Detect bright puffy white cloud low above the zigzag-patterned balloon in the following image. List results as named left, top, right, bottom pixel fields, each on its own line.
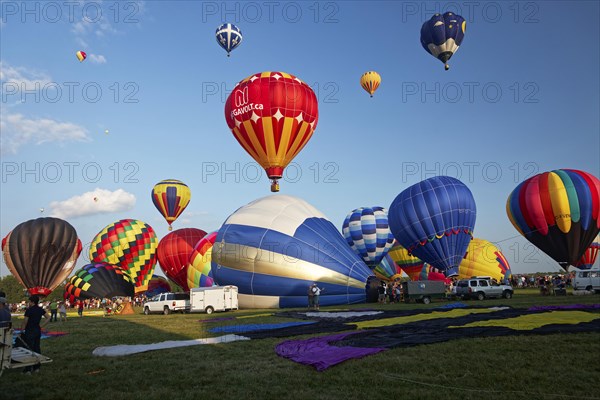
left=50, top=188, right=136, bottom=219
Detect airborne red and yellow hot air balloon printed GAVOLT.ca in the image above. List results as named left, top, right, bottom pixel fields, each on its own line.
left=225, top=72, right=319, bottom=192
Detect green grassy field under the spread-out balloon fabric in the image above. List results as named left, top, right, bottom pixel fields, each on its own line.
left=0, top=289, right=600, bottom=400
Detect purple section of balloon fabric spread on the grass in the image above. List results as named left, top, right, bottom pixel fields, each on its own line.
left=275, top=332, right=387, bottom=371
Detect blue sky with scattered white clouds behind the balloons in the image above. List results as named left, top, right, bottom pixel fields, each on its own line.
left=0, top=1, right=600, bottom=276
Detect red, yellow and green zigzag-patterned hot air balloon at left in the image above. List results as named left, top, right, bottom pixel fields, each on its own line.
left=90, top=219, right=158, bottom=293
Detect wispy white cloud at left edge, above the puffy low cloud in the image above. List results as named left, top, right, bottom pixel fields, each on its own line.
left=0, top=112, right=90, bottom=155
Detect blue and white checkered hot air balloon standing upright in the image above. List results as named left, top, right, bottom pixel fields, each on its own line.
left=342, top=207, right=394, bottom=268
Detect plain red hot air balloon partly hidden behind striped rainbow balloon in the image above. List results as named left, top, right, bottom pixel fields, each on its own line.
left=156, top=228, right=206, bottom=292
